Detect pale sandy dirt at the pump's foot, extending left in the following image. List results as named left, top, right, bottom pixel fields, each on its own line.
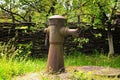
left=12, top=72, right=70, bottom=80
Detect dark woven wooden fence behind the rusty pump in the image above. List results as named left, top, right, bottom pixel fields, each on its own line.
left=0, top=23, right=120, bottom=56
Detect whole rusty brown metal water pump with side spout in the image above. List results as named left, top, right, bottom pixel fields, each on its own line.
left=45, top=15, right=78, bottom=73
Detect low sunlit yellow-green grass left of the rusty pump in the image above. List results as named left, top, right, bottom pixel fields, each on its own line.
left=0, top=58, right=46, bottom=80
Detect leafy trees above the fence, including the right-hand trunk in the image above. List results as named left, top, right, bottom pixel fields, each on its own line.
left=0, top=0, right=120, bottom=56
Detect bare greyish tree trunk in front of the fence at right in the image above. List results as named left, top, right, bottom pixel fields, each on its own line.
left=108, top=29, right=114, bottom=56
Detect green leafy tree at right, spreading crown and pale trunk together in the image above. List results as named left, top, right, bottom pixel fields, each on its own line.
left=58, top=0, right=120, bottom=56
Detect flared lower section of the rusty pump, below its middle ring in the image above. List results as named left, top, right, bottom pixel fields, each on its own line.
left=47, top=44, right=65, bottom=73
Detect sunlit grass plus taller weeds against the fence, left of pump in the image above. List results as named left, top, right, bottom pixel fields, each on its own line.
left=0, top=41, right=46, bottom=80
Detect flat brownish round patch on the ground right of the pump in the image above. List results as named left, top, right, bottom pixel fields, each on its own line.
left=75, top=66, right=120, bottom=77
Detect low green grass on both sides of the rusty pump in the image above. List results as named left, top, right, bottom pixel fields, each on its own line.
left=0, top=53, right=120, bottom=80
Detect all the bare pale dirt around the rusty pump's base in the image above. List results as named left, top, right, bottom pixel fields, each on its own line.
left=12, top=66, right=120, bottom=80
